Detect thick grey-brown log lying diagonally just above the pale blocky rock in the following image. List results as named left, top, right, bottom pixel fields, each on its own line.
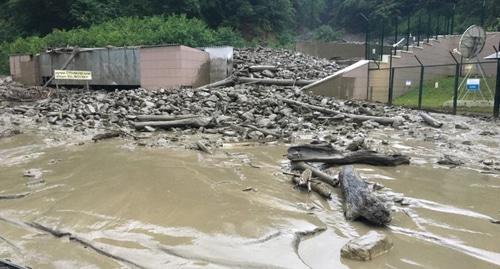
left=339, top=165, right=392, bottom=226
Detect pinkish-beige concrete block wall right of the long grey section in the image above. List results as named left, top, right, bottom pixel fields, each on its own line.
left=140, top=46, right=210, bottom=88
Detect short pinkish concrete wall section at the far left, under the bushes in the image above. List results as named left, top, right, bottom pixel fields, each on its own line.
left=9, top=54, right=40, bottom=86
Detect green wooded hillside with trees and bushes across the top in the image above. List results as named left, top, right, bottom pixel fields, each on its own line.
left=0, top=0, right=500, bottom=73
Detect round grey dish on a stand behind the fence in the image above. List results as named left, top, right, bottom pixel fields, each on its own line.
left=458, top=25, right=486, bottom=59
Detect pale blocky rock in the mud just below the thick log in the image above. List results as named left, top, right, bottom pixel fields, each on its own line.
left=341, top=231, right=393, bottom=261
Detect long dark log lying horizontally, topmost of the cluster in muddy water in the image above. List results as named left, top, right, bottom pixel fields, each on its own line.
left=288, top=144, right=410, bottom=166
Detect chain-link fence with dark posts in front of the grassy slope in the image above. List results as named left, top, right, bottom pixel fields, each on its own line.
left=380, top=61, right=497, bottom=115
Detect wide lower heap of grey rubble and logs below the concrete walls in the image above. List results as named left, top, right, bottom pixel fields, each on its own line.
left=1, top=85, right=409, bottom=146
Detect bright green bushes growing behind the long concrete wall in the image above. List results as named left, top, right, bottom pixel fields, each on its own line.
left=0, top=15, right=243, bottom=73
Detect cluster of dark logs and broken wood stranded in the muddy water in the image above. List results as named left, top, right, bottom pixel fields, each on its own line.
left=287, top=144, right=410, bottom=226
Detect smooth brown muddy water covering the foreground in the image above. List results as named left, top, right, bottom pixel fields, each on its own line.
left=0, top=135, right=500, bottom=269
